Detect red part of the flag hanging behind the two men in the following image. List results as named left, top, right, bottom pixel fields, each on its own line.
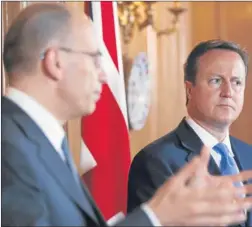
left=82, top=2, right=130, bottom=219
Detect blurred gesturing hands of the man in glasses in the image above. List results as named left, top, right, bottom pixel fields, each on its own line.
left=148, top=147, right=252, bottom=226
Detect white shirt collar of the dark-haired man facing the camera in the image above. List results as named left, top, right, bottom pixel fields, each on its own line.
left=186, top=116, right=234, bottom=156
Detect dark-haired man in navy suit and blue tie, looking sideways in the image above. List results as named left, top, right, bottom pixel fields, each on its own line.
left=128, top=40, right=252, bottom=226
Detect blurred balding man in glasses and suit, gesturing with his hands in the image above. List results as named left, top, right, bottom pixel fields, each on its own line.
left=1, top=3, right=252, bottom=226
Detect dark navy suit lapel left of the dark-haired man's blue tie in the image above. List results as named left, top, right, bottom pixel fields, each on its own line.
left=176, top=118, right=220, bottom=175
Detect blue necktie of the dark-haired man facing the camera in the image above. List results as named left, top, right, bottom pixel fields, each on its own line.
left=213, top=143, right=238, bottom=175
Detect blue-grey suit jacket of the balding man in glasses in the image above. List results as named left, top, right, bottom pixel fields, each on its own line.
left=1, top=97, right=151, bottom=226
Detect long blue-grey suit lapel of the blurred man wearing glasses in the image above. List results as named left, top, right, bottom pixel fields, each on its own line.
left=2, top=98, right=97, bottom=223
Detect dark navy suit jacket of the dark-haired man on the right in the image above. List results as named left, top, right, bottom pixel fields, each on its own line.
left=128, top=119, right=252, bottom=226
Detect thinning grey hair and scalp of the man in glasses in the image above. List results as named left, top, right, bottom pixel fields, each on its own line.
left=3, top=3, right=71, bottom=73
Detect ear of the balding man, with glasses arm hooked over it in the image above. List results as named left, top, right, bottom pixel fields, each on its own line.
left=42, top=48, right=62, bottom=80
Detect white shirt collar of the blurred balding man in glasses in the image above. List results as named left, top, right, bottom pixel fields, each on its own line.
left=6, top=87, right=65, bottom=151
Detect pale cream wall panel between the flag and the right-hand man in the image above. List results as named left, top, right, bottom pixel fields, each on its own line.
left=123, top=2, right=190, bottom=158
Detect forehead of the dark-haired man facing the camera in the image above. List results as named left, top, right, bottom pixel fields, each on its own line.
left=198, top=49, right=245, bottom=73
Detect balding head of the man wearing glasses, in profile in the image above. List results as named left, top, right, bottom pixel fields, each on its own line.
left=4, top=3, right=106, bottom=122
